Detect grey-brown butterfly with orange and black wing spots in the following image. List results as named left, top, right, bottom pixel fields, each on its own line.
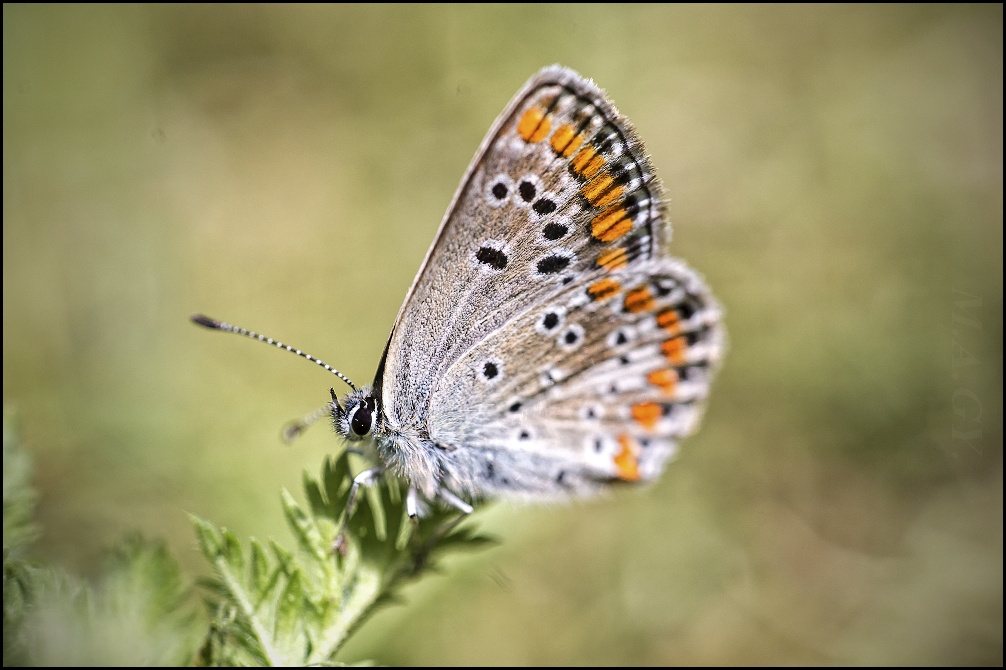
left=193, top=65, right=725, bottom=514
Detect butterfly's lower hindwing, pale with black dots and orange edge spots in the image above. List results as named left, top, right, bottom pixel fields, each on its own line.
left=430, top=259, right=723, bottom=498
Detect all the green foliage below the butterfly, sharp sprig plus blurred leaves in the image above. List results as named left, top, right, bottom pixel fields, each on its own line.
left=3, top=412, right=491, bottom=665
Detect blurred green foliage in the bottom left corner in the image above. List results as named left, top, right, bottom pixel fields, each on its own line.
left=3, top=413, right=200, bottom=666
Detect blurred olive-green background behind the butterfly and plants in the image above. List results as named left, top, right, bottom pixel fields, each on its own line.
left=3, top=4, right=1003, bottom=664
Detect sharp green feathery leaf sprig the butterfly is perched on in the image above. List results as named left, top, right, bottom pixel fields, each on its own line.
left=193, top=454, right=490, bottom=665
